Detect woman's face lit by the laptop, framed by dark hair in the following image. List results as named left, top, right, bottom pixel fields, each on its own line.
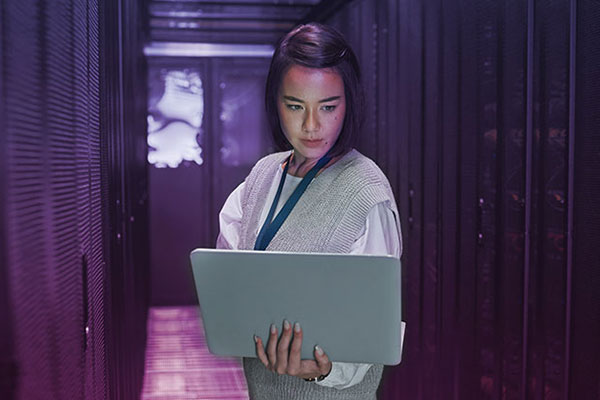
left=277, top=64, right=346, bottom=160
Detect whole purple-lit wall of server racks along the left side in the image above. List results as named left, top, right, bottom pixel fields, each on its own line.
left=0, top=0, right=148, bottom=400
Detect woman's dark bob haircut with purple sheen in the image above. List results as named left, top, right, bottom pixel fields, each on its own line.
left=265, top=22, right=365, bottom=157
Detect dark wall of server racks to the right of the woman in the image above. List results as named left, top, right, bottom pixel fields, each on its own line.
left=326, top=0, right=600, bottom=400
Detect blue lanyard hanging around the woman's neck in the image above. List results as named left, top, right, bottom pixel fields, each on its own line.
left=254, top=154, right=331, bottom=250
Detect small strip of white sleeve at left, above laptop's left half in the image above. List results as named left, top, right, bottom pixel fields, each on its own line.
left=216, top=181, right=246, bottom=250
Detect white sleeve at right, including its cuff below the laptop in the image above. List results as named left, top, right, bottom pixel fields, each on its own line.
left=317, top=201, right=402, bottom=389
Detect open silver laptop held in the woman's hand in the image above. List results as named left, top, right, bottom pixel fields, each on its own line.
left=190, top=249, right=404, bottom=365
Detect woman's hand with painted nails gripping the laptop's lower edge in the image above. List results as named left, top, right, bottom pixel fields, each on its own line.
left=254, top=321, right=332, bottom=379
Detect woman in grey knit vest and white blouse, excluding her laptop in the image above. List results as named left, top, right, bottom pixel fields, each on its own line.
left=217, top=23, right=402, bottom=400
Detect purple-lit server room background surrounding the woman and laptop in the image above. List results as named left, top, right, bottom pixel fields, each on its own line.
left=0, top=0, right=600, bottom=400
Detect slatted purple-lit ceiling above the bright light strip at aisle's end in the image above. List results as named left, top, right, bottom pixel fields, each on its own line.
left=148, top=0, right=350, bottom=45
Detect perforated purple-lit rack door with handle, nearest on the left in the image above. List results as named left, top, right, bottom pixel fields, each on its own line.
left=0, top=0, right=107, bottom=399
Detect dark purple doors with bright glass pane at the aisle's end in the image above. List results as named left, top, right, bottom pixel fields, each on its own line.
left=147, top=56, right=273, bottom=305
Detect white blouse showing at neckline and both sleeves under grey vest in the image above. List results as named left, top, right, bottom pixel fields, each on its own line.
left=217, top=164, right=402, bottom=389
